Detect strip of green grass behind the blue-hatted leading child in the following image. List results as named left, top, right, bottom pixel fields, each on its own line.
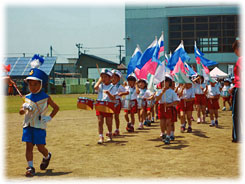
left=4, top=94, right=97, bottom=113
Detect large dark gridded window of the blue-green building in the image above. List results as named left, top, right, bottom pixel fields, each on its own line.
left=169, top=15, right=239, bottom=53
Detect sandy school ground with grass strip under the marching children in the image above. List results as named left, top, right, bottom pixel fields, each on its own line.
left=4, top=95, right=241, bottom=181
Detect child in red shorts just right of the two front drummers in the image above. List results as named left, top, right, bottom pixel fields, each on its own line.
left=124, top=75, right=137, bottom=132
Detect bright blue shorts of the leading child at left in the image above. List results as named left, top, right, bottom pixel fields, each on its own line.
left=22, top=127, right=46, bottom=145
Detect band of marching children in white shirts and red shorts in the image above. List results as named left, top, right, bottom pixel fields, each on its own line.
left=95, top=69, right=234, bottom=144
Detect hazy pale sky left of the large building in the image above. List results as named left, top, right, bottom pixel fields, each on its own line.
left=4, top=4, right=125, bottom=62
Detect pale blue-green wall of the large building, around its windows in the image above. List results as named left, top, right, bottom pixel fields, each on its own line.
left=125, top=5, right=240, bottom=72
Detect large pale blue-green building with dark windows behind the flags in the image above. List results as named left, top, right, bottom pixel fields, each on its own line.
left=125, top=5, right=240, bottom=72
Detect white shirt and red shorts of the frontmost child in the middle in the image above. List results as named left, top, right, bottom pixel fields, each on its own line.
left=156, top=88, right=179, bottom=119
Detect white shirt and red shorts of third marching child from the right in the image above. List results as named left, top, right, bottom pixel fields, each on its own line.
left=194, top=83, right=207, bottom=106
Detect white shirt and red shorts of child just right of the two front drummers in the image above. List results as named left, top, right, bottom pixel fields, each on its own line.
left=124, top=86, right=138, bottom=113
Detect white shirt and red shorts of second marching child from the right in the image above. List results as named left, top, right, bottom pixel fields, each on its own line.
left=207, top=85, right=220, bottom=109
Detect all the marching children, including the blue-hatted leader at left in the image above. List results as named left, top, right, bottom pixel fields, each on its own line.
left=19, top=52, right=234, bottom=176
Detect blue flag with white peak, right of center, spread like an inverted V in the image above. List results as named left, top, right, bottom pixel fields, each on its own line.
left=167, top=40, right=191, bottom=71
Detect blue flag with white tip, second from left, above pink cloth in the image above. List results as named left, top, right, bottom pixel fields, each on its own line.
left=136, top=37, right=158, bottom=69
